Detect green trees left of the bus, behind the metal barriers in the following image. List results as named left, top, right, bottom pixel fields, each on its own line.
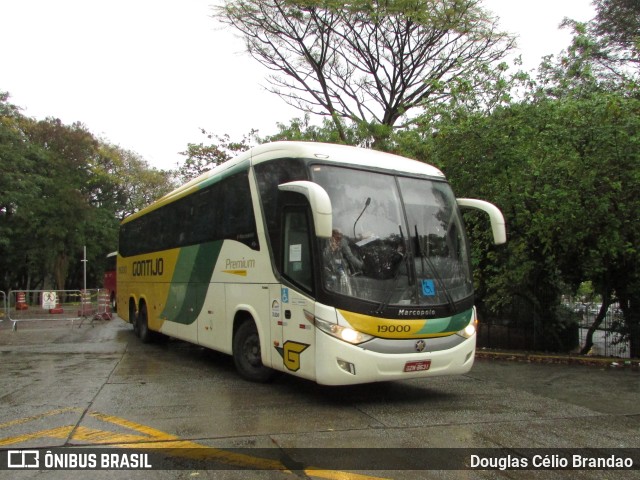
left=0, top=94, right=172, bottom=290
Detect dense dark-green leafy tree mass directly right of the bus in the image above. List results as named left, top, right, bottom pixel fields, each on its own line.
left=420, top=93, right=640, bottom=357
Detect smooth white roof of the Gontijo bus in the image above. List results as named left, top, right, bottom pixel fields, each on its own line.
left=124, top=141, right=444, bottom=223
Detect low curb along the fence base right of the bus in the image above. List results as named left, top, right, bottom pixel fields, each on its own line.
left=476, top=350, right=640, bottom=370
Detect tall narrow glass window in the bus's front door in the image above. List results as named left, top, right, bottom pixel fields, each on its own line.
left=282, top=209, right=313, bottom=292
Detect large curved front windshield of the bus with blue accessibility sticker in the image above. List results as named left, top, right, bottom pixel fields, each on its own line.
left=311, top=165, right=473, bottom=309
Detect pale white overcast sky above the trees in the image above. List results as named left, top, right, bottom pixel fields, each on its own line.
left=0, top=0, right=594, bottom=169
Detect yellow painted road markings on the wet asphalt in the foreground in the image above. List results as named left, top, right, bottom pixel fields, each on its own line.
left=0, top=408, right=388, bottom=480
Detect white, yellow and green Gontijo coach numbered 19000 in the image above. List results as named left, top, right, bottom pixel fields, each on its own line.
left=117, top=142, right=506, bottom=385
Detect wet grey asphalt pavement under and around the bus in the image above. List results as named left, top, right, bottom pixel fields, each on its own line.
left=0, top=318, right=640, bottom=479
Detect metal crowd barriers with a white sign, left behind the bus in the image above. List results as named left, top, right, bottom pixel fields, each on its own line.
left=5, top=289, right=111, bottom=330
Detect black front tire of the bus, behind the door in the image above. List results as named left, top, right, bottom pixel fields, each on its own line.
left=233, top=320, right=274, bottom=383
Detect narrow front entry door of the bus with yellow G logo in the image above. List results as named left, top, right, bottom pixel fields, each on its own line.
left=274, top=206, right=315, bottom=378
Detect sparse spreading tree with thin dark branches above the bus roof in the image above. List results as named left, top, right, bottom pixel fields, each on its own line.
left=215, top=0, right=513, bottom=142
